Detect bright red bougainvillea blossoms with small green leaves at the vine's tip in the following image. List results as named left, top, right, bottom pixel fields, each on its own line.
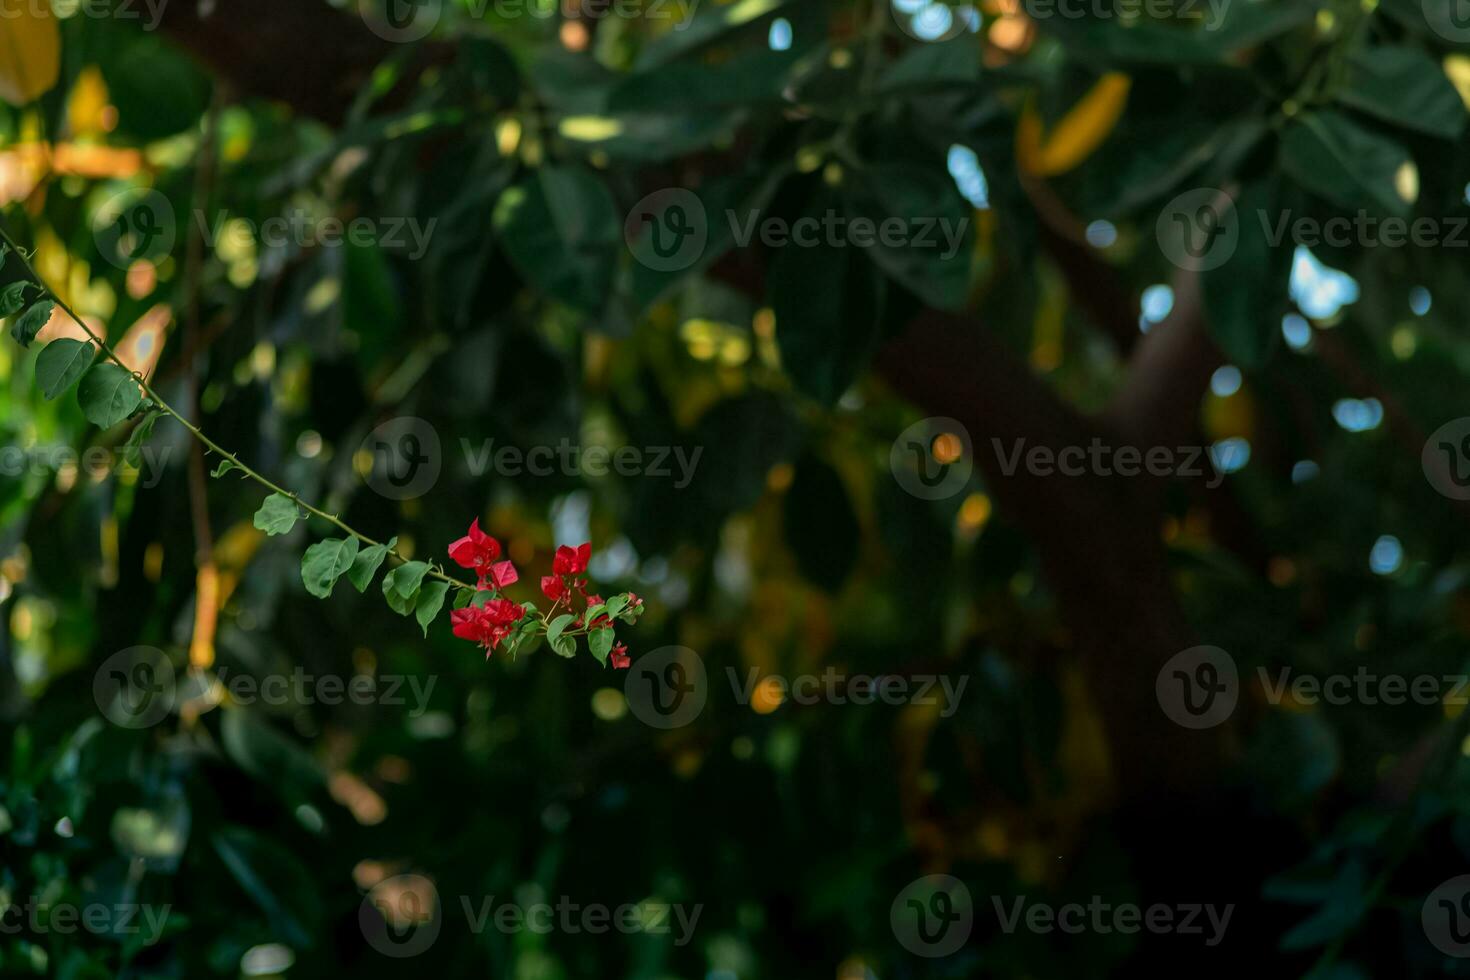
left=450, top=519, right=644, bottom=669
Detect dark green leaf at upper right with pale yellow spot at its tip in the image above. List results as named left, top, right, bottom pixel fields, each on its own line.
left=1282, top=110, right=1411, bottom=216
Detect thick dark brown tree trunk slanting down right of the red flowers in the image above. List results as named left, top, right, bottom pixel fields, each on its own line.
left=876, top=311, right=1226, bottom=805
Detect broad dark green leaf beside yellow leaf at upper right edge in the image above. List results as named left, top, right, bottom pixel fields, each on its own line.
left=1338, top=44, right=1466, bottom=140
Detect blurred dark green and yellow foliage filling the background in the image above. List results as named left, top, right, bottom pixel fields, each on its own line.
left=0, top=0, right=1470, bottom=980
